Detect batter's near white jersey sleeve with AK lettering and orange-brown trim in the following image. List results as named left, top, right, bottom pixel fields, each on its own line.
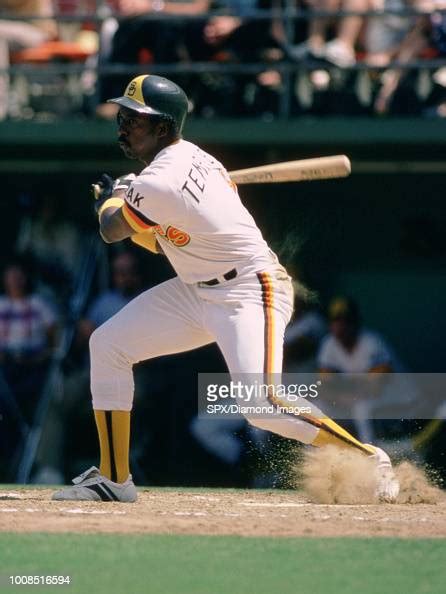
left=122, top=173, right=186, bottom=232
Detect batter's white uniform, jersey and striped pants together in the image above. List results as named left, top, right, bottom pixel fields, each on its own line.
left=90, top=140, right=324, bottom=443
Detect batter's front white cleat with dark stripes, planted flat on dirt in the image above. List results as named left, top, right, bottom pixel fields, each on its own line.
left=52, top=466, right=138, bottom=503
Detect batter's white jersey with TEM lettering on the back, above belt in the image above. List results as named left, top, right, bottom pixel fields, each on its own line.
left=123, top=140, right=271, bottom=284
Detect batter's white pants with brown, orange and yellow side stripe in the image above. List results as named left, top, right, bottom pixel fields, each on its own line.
left=90, top=265, right=318, bottom=443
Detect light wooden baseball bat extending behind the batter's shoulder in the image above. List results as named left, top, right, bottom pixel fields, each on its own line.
left=229, top=155, right=351, bottom=184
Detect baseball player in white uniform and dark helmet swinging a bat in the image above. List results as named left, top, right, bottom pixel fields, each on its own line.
left=53, top=75, right=398, bottom=502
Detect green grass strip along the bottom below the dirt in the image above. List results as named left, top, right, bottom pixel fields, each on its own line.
left=0, top=532, right=446, bottom=594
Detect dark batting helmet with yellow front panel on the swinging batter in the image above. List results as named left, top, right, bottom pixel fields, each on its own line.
left=108, top=74, right=189, bottom=132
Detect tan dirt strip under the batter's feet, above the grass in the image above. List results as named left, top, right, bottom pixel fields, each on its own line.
left=0, top=488, right=446, bottom=538
